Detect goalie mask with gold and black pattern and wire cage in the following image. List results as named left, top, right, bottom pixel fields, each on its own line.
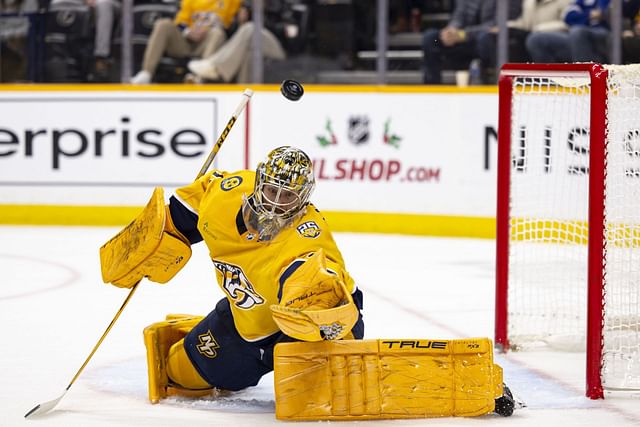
left=242, top=146, right=315, bottom=241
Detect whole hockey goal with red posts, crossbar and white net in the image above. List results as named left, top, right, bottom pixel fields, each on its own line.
left=495, top=63, right=640, bottom=399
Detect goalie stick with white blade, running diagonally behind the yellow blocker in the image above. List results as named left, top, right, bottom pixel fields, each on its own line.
left=24, top=89, right=253, bottom=418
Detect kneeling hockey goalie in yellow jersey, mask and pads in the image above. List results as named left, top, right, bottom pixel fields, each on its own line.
left=100, top=146, right=513, bottom=420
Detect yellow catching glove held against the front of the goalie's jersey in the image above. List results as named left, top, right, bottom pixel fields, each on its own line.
left=271, top=250, right=359, bottom=341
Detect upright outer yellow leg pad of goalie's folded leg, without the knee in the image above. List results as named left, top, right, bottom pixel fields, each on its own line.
left=144, top=314, right=204, bottom=403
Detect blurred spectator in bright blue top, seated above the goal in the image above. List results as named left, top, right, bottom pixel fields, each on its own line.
left=564, top=0, right=609, bottom=63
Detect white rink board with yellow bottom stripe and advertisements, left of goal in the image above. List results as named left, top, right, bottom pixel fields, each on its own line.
left=0, top=85, right=497, bottom=237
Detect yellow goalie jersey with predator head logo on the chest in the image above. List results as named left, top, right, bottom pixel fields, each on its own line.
left=169, top=170, right=355, bottom=341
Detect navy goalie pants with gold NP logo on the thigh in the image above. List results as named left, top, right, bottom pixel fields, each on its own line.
left=184, top=290, right=364, bottom=391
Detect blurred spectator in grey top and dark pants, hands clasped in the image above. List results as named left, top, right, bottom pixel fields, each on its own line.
left=422, top=0, right=522, bottom=84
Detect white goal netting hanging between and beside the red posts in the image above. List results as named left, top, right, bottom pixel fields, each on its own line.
left=507, top=66, right=640, bottom=389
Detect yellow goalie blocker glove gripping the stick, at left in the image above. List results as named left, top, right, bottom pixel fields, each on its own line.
left=100, top=187, right=191, bottom=288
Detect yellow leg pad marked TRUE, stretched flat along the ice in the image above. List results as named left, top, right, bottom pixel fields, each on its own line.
left=274, top=338, right=502, bottom=421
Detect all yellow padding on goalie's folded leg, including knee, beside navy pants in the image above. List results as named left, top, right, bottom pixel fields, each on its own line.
left=144, top=314, right=211, bottom=403
